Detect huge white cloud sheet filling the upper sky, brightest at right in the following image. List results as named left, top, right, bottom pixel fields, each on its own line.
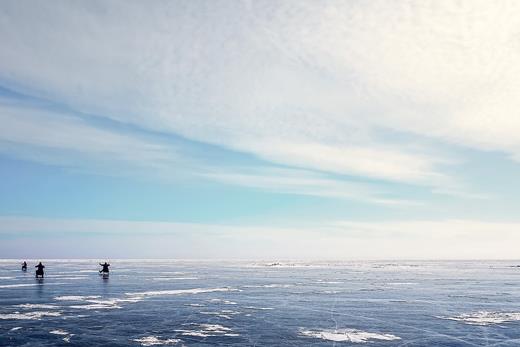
left=6, top=1, right=520, bottom=186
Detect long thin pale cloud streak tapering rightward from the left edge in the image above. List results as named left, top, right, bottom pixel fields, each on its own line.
left=0, top=97, right=410, bottom=205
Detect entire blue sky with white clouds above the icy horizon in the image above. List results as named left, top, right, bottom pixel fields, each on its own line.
left=0, top=0, right=520, bottom=260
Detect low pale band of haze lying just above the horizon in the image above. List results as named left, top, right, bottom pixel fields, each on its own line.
left=0, top=217, right=520, bottom=260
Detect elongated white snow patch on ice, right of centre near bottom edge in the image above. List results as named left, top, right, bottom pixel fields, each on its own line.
left=300, top=329, right=401, bottom=343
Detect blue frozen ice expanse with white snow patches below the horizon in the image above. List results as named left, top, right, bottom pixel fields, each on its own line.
left=0, top=260, right=520, bottom=347
